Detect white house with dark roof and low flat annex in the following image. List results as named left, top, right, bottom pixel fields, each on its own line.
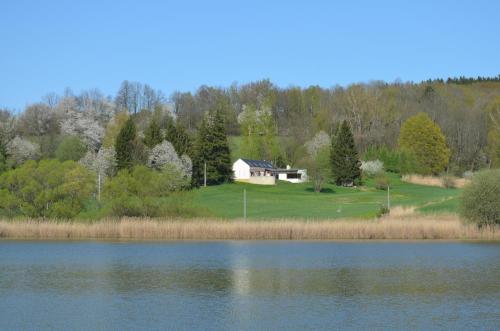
left=233, top=159, right=307, bottom=185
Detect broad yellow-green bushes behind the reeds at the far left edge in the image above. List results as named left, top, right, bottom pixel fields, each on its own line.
left=0, top=160, right=95, bottom=218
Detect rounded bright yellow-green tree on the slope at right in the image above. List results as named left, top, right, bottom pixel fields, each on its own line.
left=398, top=113, right=451, bottom=175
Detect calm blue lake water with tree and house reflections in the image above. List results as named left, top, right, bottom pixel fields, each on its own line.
left=0, top=241, right=500, bottom=330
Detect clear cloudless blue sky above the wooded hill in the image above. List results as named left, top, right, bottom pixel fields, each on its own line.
left=0, top=0, right=500, bottom=110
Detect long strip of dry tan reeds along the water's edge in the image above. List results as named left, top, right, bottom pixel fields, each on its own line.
left=0, top=213, right=500, bottom=240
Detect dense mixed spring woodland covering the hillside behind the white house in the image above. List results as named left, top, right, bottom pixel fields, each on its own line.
left=0, top=76, right=500, bottom=216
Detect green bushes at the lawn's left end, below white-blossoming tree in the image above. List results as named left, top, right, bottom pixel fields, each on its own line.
left=104, top=166, right=189, bottom=217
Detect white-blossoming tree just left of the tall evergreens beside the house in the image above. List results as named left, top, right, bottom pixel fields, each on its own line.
left=148, top=140, right=193, bottom=178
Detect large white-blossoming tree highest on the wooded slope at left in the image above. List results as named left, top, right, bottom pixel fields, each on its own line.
left=61, top=109, right=104, bottom=151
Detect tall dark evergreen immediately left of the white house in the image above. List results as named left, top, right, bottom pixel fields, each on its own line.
left=192, top=109, right=233, bottom=186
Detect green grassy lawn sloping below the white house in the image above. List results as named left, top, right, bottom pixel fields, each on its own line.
left=193, top=175, right=461, bottom=219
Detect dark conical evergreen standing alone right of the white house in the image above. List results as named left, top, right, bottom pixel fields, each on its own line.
left=331, top=121, right=361, bottom=186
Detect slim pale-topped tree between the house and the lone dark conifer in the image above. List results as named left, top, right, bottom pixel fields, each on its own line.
left=306, top=131, right=331, bottom=192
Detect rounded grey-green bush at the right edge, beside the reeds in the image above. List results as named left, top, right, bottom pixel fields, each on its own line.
left=460, top=169, right=500, bottom=226
